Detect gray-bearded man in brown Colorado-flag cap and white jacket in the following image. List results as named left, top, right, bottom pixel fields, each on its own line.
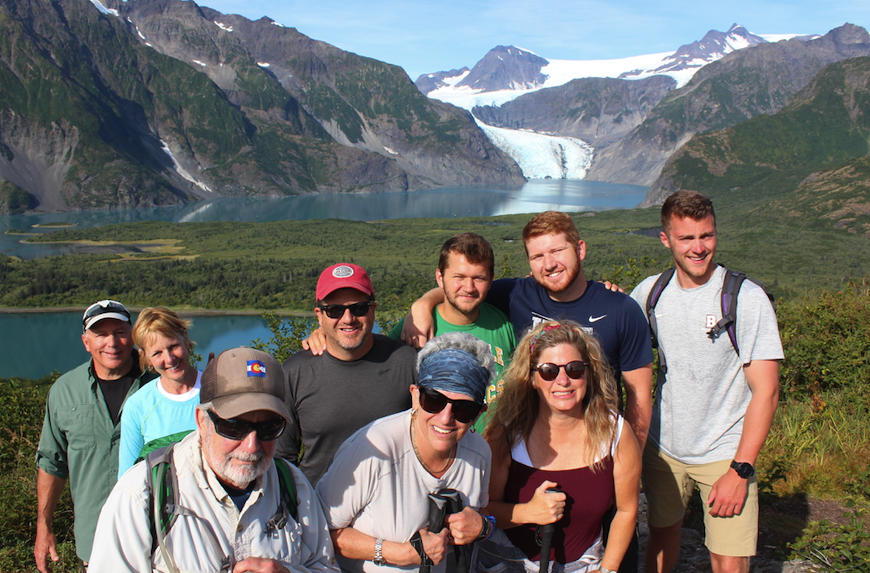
left=90, top=348, right=338, bottom=573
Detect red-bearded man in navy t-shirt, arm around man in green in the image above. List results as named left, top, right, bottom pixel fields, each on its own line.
left=402, top=211, right=652, bottom=573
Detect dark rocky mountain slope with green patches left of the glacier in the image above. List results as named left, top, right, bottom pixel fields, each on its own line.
left=0, top=0, right=523, bottom=210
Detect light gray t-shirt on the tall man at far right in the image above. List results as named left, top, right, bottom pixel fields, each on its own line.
left=631, top=267, right=783, bottom=464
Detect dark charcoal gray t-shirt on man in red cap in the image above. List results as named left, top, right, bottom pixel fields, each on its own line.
left=277, top=334, right=417, bottom=485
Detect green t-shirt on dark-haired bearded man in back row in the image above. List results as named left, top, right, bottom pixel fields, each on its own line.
left=389, top=302, right=517, bottom=432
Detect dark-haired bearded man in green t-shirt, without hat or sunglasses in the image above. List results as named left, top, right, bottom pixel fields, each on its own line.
left=390, top=233, right=517, bottom=433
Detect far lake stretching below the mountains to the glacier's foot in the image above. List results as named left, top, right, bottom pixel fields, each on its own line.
left=0, top=179, right=648, bottom=258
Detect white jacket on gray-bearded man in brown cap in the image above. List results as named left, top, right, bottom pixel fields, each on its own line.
left=88, top=432, right=339, bottom=573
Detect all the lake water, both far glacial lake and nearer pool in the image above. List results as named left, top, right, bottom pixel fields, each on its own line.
left=0, top=180, right=647, bottom=378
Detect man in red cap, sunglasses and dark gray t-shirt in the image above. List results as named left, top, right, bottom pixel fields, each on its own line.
left=278, top=263, right=417, bottom=485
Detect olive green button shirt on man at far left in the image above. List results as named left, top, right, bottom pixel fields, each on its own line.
left=36, top=358, right=153, bottom=562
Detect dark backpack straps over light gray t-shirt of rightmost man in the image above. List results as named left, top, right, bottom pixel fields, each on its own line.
left=646, top=265, right=775, bottom=374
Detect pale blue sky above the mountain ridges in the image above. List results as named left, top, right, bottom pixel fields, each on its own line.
left=197, top=0, right=870, bottom=79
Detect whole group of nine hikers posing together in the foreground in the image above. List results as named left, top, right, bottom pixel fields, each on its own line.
left=34, top=192, right=783, bottom=573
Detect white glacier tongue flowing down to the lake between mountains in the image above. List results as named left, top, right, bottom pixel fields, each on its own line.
left=477, top=121, right=594, bottom=179
